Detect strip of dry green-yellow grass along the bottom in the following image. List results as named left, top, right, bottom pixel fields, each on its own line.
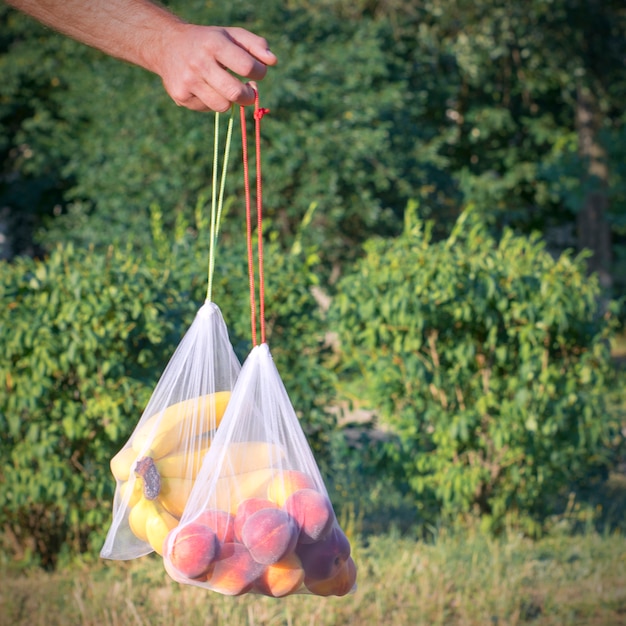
left=0, top=532, right=626, bottom=626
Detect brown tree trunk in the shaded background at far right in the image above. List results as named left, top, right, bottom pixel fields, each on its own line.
left=576, top=86, right=612, bottom=287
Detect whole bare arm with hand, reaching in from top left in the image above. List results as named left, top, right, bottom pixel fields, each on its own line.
left=7, top=0, right=276, bottom=111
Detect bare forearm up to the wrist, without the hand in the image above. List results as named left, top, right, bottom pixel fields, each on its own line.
left=7, top=0, right=184, bottom=71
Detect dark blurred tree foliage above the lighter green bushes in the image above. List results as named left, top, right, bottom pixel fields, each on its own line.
left=0, top=0, right=626, bottom=282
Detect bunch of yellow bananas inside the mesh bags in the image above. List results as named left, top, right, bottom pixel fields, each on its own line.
left=111, top=391, right=284, bottom=555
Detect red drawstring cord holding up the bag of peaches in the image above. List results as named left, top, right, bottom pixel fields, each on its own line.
left=240, top=90, right=269, bottom=346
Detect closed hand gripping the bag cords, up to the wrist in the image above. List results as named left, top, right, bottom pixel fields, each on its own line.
left=153, top=24, right=277, bottom=112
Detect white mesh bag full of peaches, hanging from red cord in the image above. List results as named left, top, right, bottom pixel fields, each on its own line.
left=163, top=343, right=356, bottom=597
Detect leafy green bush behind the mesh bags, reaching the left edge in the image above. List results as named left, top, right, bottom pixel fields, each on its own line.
left=0, top=209, right=335, bottom=567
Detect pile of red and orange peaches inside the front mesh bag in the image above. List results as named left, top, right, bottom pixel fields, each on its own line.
left=163, top=470, right=356, bottom=598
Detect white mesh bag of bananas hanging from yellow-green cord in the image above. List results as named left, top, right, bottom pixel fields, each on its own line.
left=100, top=301, right=241, bottom=560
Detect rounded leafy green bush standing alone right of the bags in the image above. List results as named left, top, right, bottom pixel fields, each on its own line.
left=330, top=210, right=618, bottom=532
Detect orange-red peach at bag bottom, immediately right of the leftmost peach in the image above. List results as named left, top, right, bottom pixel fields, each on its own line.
left=205, top=543, right=265, bottom=596
